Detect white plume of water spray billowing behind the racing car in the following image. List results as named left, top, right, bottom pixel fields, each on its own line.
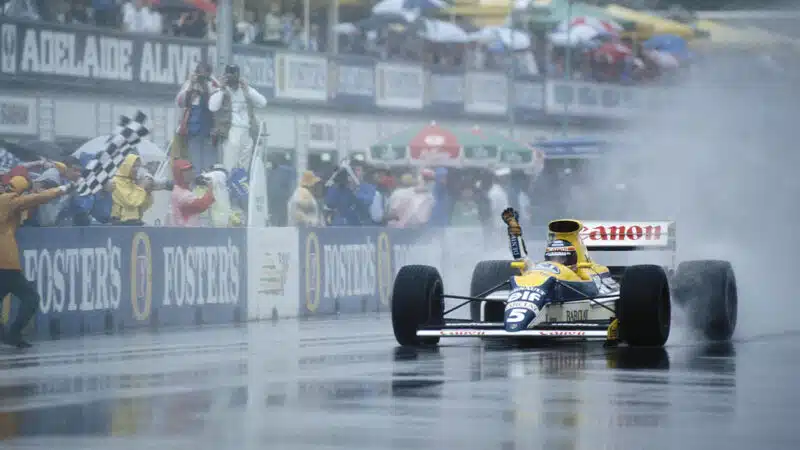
left=584, top=26, right=800, bottom=339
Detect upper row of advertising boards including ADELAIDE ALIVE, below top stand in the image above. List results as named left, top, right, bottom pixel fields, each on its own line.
left=0, top=17, right=649, bottom=122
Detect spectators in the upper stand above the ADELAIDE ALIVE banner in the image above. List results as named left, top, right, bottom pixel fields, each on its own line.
left=3, top=0, right=704, bottom=83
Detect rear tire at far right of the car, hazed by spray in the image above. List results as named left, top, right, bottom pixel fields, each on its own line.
left=673, top=260, right=739, bottom=341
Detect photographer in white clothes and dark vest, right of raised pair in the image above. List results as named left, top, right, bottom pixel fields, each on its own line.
left=208, top=64, right=267, bottom=173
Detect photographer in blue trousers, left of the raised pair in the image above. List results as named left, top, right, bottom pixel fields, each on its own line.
left=172, top=62, right=219, bottom=169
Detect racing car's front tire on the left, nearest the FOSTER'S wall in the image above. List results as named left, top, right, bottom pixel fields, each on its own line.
left=391, top=266, right=444, bottom=346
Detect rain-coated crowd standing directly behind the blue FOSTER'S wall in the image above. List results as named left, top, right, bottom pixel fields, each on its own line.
left=0, top=138, right=544, bottom=229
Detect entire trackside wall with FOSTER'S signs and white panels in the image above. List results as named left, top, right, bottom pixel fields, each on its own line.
left=2, top=227, right=552, bottom=339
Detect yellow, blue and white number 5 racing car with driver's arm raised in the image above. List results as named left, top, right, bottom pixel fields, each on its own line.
left=391, top=208, right=738, bottom=347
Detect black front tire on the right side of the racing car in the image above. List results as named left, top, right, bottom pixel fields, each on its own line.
left=617, top=265, right=672, bottom=347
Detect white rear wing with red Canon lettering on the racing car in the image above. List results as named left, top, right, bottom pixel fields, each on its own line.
left=580, top=221, right=676, bottom=252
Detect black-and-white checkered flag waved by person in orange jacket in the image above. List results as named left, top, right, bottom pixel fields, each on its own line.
left=76, top=111, right=150, bottom=196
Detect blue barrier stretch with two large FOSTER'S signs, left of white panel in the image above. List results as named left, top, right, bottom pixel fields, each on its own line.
left=16, top=227, right=247, bottom=338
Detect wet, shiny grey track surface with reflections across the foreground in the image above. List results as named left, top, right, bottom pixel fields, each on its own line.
left=0, top=318, right=800, bottom=450
